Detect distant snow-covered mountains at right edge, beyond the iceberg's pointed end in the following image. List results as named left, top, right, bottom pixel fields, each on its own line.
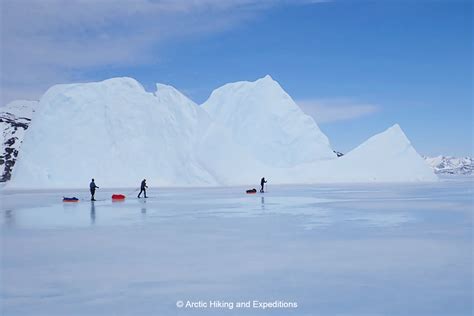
left=423, top=156, right=474, bottom=175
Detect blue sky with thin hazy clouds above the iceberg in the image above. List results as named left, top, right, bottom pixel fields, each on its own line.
left=0, top=0, right=474, bottom=156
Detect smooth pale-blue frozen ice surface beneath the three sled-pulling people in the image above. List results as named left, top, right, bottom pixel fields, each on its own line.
left=0, top=178, right=474, bottom=315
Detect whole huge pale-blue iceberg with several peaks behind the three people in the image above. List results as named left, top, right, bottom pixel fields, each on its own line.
left=3, top=76, right=437, bottom=188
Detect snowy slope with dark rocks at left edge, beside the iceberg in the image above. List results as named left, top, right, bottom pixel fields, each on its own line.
left=0, top=100, right=38, bottom=182
